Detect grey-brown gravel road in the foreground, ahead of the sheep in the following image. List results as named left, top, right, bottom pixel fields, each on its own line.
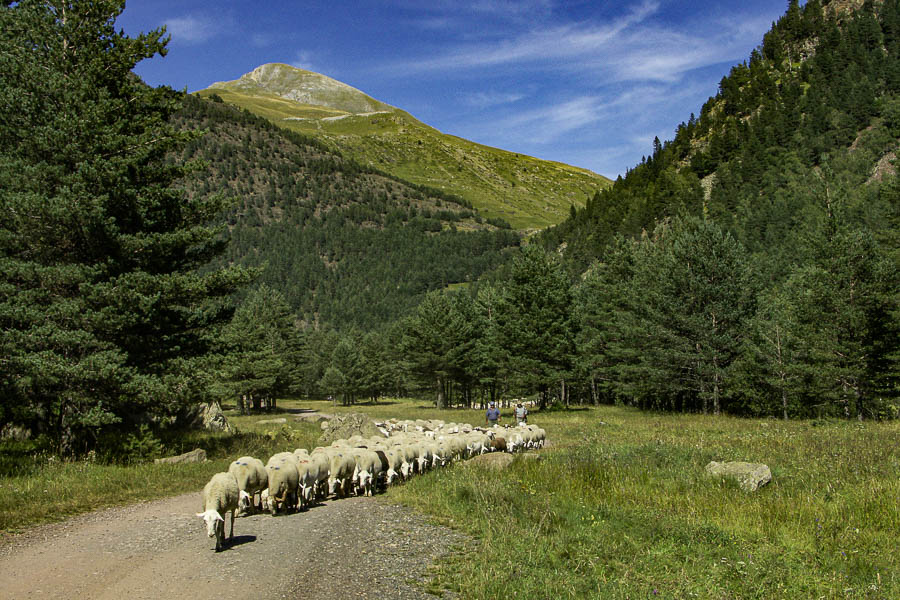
left=0, top=492, right=471, bottom=600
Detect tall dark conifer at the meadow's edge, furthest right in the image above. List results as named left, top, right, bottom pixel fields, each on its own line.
left=788, top=201, right=900, bottom=419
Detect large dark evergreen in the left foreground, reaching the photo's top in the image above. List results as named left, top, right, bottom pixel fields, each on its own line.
left=0, top=0, right=247, bottom=451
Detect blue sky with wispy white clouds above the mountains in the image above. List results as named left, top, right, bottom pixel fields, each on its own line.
left=117, top=0, right=787, bottom=178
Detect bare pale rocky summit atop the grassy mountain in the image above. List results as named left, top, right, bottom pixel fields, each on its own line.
left=209, top=63, right=396, bottom=114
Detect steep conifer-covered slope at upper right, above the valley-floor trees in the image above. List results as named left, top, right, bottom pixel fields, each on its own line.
left=544, top=0, right=900, bottom=271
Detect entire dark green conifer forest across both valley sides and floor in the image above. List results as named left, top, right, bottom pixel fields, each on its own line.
left=0, top=0, right=900, bottom=455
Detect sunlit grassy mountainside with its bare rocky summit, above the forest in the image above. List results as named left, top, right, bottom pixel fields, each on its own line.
left=198, top=64, right=610, bottom=230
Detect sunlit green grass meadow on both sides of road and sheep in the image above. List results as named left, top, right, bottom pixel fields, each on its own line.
left=0, top=401, right=900, bottom=598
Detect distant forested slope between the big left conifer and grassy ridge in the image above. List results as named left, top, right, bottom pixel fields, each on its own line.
left=179, top=96, right=519, bottom=329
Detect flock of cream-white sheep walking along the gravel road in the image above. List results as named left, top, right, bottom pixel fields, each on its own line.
left=197, top=419, right=546, bottom=552
